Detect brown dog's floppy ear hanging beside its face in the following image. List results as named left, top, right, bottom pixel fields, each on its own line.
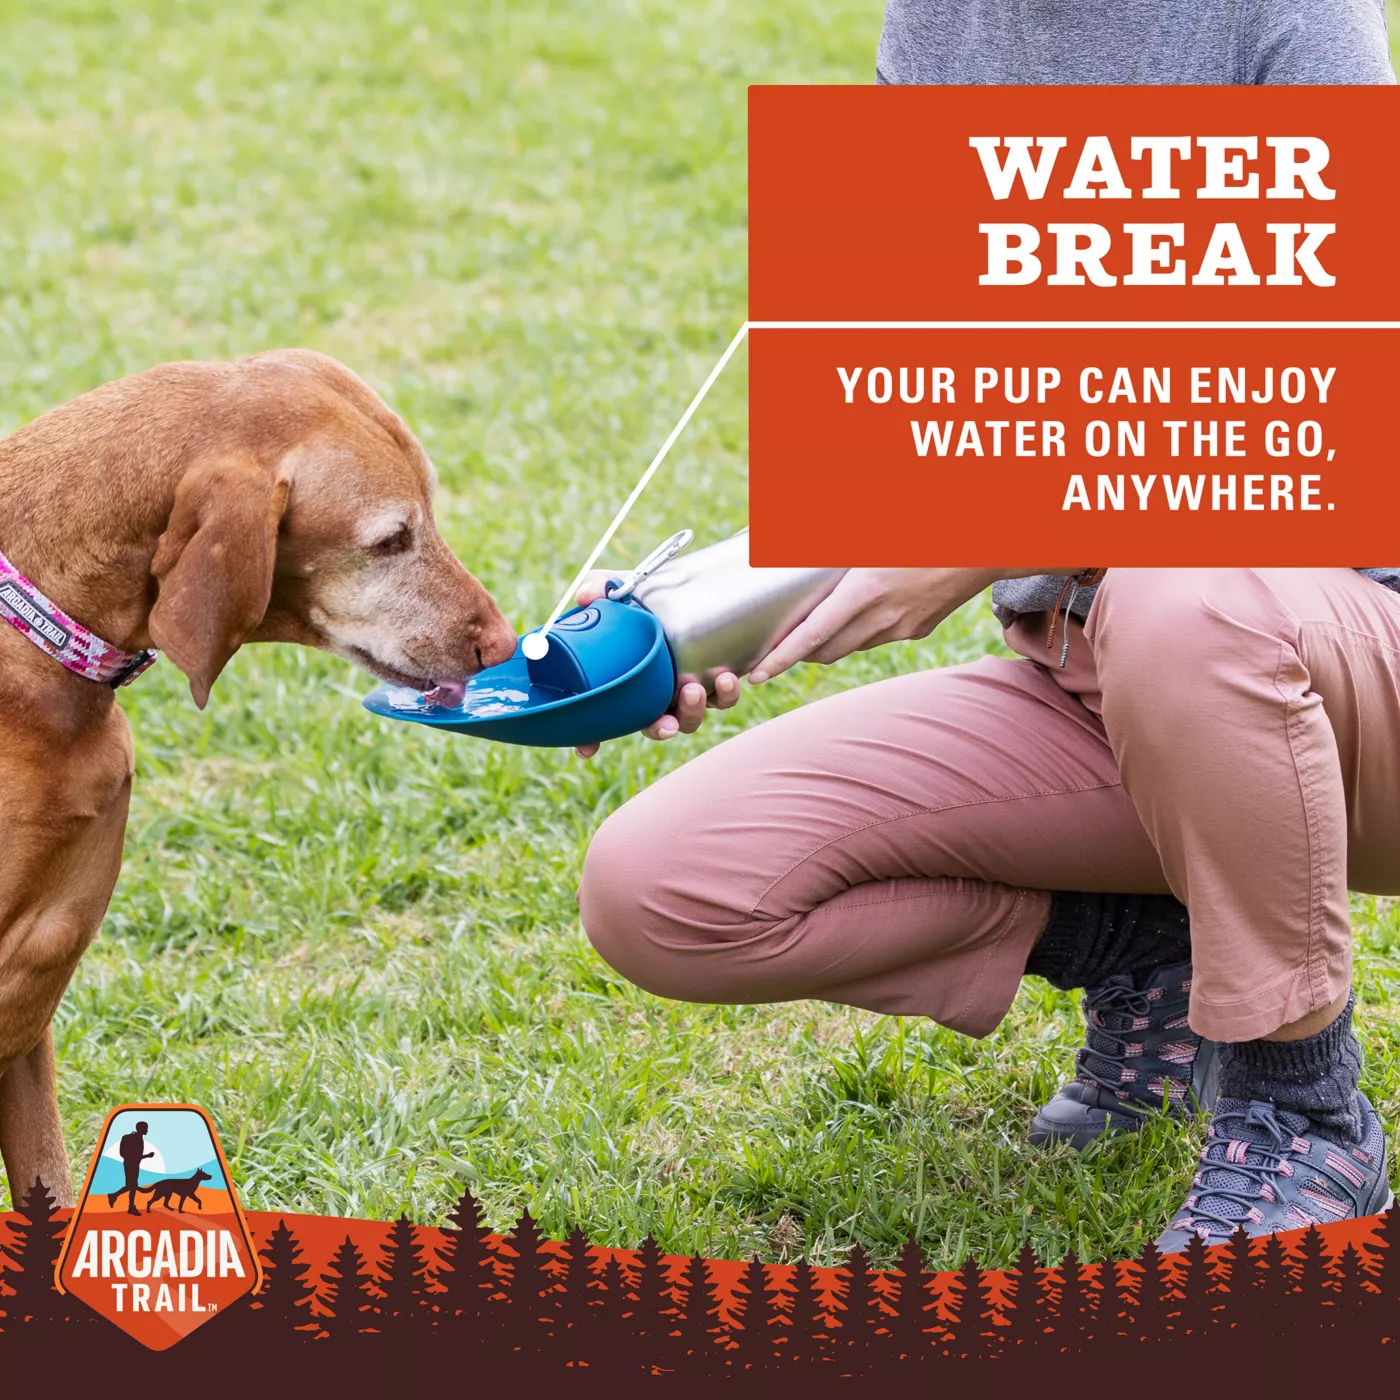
left=150, top=454, right=290, bottom=710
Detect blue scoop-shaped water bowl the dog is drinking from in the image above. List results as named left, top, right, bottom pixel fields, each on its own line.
left=364, top=599, right=676, bottom=749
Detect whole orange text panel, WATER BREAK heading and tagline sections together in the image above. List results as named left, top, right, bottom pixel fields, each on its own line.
left=749, top=87, right=1400, bottom=567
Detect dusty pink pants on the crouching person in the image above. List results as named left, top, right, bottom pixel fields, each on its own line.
left=580, top=568, right=1400, bottom=1040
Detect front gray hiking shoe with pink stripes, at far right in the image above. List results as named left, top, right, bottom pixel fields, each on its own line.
left=1156, top=1093, right=1394, bottom=1254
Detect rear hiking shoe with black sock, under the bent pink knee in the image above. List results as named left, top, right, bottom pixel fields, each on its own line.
left=1030, top=962, right=1218, bottom=1151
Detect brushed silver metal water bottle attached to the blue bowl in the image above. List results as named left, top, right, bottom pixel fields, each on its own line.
left=627, top=528, right=846, bottom=690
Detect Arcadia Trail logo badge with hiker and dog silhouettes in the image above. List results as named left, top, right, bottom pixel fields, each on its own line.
left=57, top=1103, right=262, bottom=1351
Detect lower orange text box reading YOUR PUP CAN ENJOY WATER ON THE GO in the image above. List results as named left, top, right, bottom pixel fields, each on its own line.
left=749, top=328, right=1400, bottom=568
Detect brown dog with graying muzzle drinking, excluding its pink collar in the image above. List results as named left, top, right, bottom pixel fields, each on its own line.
left=0, top=350, right=515, bottom=1204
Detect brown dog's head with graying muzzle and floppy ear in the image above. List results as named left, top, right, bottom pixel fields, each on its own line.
left=150, top=350, right=515, bottom=708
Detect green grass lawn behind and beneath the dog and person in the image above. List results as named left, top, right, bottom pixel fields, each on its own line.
left=0, top=0, right=1400, bottom=1266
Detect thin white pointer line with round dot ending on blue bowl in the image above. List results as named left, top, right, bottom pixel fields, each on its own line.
left=532, top=312, right=1400, bottom=659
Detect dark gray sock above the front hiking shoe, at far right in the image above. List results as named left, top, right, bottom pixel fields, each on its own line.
left=1219, top=995, right=1362, bottom=1144
